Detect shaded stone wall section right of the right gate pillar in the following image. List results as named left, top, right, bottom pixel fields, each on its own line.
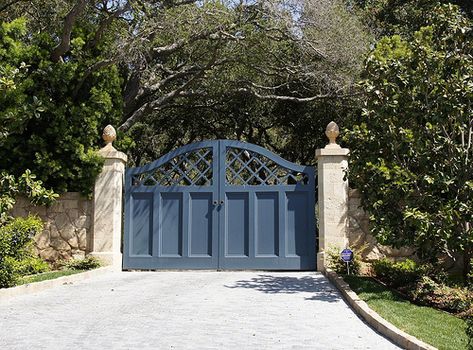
left=348, top=189, right=414, bottom=261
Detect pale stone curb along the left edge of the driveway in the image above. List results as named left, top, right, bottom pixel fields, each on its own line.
left=0, top=266, right=116, bottom=300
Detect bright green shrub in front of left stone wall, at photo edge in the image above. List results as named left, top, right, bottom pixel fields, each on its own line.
left=0, top=216, right=43, bottom=288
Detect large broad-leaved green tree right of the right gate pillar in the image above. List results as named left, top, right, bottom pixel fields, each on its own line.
left=346, top=5, right=473, bottom=275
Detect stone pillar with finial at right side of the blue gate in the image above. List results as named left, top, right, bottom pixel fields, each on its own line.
left=315, top=122, right=349, bottom=271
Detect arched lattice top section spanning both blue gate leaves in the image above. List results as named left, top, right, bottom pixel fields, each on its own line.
left=127, top=140, right=314, bottom=186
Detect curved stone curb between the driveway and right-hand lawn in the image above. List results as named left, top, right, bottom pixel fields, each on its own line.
left=324, top=269, right=437, bottom=350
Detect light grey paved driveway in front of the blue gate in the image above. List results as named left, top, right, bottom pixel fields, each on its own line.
left=0, top=271, right=397, bottom=350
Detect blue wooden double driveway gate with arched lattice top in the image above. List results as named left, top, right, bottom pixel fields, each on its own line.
left=123, top=140, right=316, bottom=270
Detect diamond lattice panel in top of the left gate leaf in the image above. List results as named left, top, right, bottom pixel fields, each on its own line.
left=133, top=148, right=213, bottom=186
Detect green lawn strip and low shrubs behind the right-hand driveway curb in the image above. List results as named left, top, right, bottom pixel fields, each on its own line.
left=326, top=247, right=473, bottom=349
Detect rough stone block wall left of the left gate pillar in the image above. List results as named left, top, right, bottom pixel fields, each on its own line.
left=11, top=192, right=93, bottom=261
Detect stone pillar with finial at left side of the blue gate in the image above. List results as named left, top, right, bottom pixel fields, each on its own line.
left=90, top=125, right=127, bottom=270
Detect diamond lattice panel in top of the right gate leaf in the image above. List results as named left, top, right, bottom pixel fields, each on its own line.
left=225, top=147, right=309, bottom=186
